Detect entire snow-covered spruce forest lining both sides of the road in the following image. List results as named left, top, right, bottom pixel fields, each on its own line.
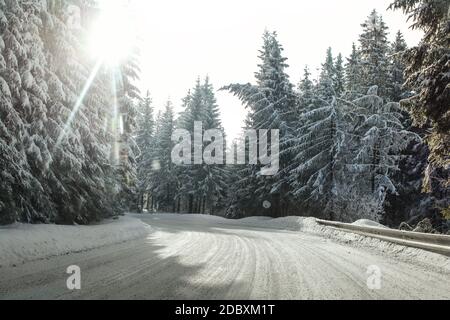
left=0, top=0, right=450, bottom=231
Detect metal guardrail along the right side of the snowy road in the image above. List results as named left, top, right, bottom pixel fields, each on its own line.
left=317, top=220, right=450, bottom=256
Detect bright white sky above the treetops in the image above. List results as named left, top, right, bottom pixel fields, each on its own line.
left=120, top=0, right=420, bottom=137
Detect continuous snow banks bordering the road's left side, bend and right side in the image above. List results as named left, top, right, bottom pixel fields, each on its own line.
left=0, top=214, right=450, bottom=270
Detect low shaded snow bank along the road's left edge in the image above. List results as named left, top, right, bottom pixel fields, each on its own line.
left=0, top=216, right=151, bottom=267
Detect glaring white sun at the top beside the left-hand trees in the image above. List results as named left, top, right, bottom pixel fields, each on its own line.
left=89, top=0, right=136, bottom=66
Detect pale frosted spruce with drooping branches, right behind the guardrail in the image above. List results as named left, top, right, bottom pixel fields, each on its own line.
left=348, top=86, right=420, bottom=220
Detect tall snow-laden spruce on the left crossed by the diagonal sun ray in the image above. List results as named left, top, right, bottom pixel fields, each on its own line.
left=43, top=1, right=118, bottom=223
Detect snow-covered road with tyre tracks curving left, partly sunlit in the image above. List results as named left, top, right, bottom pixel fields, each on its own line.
left=0, top=215, right=450, bottom=299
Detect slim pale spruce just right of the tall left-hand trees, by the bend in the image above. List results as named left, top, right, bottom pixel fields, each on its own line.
left=135, top=91, right=155, bottom=211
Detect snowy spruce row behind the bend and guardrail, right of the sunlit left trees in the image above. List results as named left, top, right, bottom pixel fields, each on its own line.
left=138, top=2, right=448, bottom=228
